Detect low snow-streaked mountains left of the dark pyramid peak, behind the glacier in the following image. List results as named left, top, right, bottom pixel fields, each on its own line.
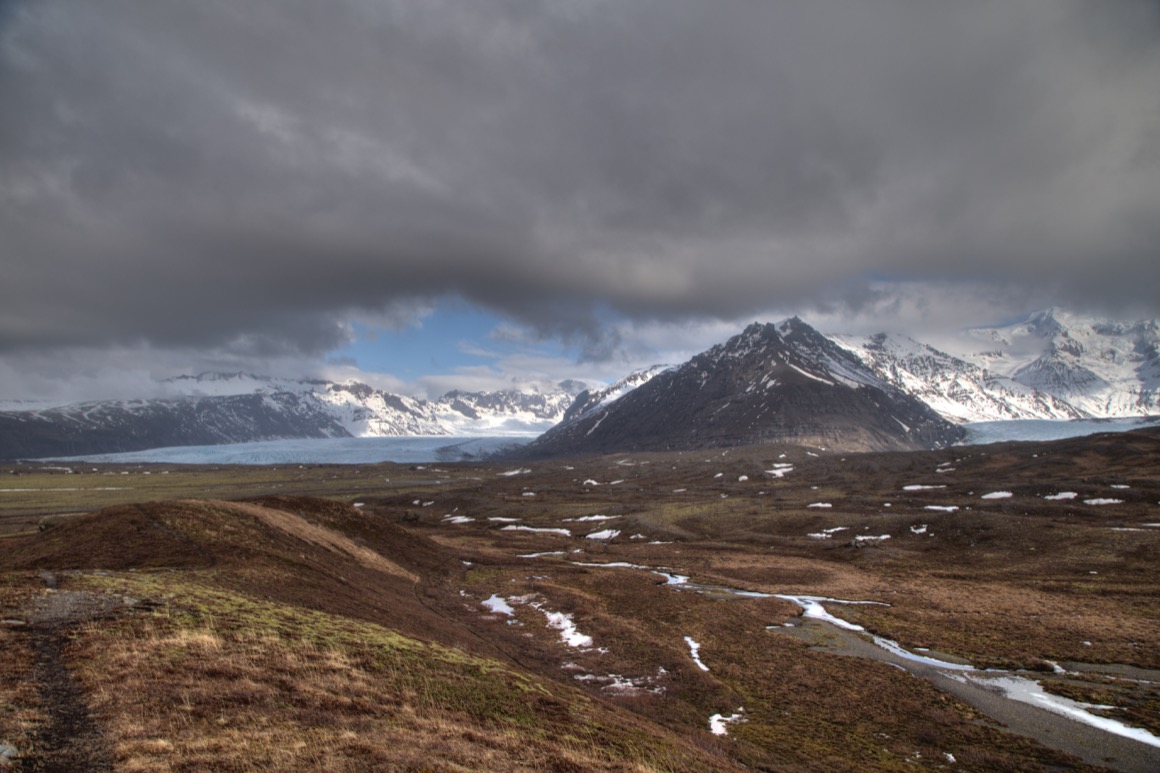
left=0, top=374, right=583, bottom=458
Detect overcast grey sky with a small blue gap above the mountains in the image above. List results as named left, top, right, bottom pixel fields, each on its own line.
left=0, top=0, right=1160, bottom=400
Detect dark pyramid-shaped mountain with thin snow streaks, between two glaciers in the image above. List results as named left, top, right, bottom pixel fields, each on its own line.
left=525, top=318, right=963, bottom=456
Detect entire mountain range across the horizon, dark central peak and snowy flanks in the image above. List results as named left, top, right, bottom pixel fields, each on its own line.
left=0, top=309, right=1160, bottom=458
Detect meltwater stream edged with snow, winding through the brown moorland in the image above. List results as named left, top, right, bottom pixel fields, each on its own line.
left=572, top=562, right=1160, bottom=773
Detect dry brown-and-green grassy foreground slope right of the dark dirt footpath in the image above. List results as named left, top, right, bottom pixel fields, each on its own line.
left=58, top=577, right=730, bottom=771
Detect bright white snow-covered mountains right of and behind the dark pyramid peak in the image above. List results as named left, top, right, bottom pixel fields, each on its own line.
left=831, top=309, right=1160, bottom=422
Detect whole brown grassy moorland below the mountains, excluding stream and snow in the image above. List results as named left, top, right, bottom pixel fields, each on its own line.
left=0, top=431, right=1160, bottom=771
